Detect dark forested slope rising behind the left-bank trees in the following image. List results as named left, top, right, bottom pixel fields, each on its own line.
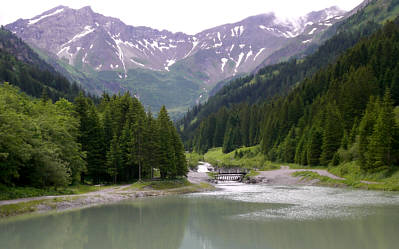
left=0, top=27, right=81, bottom=101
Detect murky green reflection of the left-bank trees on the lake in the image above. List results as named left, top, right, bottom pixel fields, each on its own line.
left=0, top=198, right=187, bottom=249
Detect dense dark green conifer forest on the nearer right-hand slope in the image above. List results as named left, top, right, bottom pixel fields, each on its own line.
left=185, top=20, right=399, bottom=171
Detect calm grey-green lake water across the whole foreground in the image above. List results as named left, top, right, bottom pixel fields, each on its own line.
left=0, top=185, right=399, bottom=249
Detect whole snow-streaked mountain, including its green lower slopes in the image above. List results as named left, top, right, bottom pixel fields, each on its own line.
left=6, top=6, right=345, bottom=115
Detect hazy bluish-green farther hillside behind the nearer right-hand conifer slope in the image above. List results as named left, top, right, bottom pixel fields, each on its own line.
left=177, top=0, right=399, bottom=148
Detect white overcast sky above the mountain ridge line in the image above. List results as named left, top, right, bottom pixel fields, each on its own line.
left=0, top=0, right=363, bottom=34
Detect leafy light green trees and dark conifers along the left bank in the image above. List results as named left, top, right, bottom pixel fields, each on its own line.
left=0, top=83, right=187, bottom=187
